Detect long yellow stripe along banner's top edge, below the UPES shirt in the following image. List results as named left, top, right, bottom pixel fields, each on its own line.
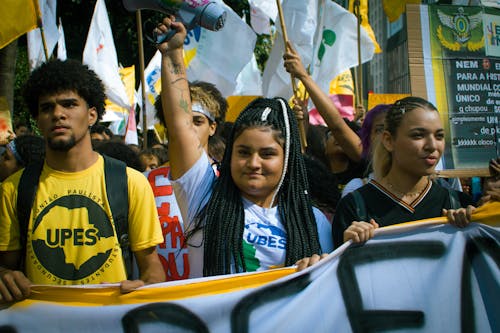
left=22, top=267, right=295, bottom=307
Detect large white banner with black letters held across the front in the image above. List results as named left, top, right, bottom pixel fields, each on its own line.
left=0, top=219, right=500, bottom=332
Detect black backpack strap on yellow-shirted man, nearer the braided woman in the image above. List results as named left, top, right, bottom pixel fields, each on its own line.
left=103, top=155, right=133, bottom=279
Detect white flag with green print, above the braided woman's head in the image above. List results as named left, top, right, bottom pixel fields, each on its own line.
left=262, top=0, right=375, bottom=98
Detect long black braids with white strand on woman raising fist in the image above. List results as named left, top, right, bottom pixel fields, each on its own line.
left=188, top=98, right=321, bottom=276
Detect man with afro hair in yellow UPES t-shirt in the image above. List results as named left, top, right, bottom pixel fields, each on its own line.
left=0, top=60, right=165, bottom=303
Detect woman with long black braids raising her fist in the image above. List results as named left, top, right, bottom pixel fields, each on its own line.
left=157, top=17, right=333, bottom=277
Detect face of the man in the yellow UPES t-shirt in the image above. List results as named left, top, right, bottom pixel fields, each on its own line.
left=37, top=91, right=97, bottom=151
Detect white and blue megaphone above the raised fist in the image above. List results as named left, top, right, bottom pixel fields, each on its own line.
left=123, top=0, right=226, bottom=43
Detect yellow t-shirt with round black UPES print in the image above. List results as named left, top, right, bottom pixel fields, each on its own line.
left=0, top=156, right=163, bottom=285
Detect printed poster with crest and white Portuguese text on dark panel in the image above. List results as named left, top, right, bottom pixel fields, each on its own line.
left=422, top=5, right=500, bottom=169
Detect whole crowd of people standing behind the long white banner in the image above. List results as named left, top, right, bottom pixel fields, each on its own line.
left=0, top=17, right=500, bottom=303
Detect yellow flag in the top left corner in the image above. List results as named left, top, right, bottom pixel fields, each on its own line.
left=0, top=0, right=39, bottom=49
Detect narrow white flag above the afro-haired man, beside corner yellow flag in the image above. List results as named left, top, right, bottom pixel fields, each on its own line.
left=28, top=0, right=59, bottom=70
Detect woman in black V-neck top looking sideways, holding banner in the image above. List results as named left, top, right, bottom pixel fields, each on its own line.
left=332, top=97, right=474, bottom=247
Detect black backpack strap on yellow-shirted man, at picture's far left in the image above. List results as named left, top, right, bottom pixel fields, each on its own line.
left=17, top=161, right=44, bottom=267
